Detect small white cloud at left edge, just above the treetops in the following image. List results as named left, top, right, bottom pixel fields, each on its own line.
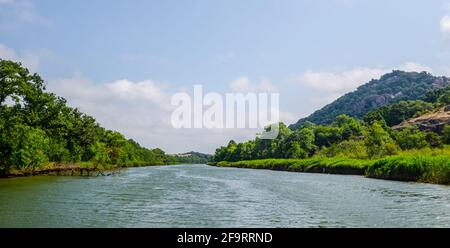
left=0, top=42, right=41, bottom=72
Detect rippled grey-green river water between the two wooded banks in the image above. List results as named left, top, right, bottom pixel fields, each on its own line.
left=0, top=165, right=450, bottom=227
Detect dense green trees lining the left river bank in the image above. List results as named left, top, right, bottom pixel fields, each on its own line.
left=0, top=60, right=174, bottom=172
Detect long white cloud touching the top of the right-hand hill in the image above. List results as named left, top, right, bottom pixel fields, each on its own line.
left=292, top=62, right=432, bottom=94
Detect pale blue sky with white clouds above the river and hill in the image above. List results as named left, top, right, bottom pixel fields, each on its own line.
left=0, top=0, right=450, bottom=153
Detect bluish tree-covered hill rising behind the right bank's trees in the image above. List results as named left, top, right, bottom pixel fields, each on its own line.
left=290, top=71, right=450, bottom=130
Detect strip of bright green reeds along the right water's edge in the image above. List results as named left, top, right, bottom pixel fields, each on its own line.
left=208, top=155, right=450, bottom=185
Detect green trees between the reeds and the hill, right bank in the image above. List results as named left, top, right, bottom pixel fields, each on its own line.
left=211, top=115, right=450, bottom=162
